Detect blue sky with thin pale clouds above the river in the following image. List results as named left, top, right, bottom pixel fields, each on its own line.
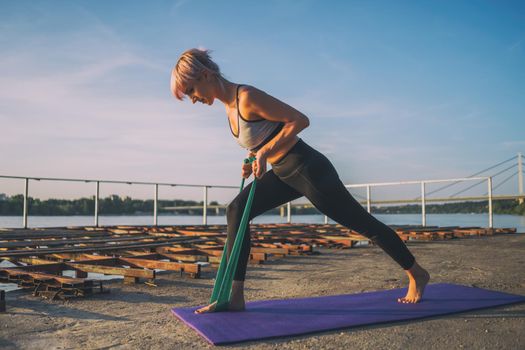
left=0, top=0, right=525, bottom=201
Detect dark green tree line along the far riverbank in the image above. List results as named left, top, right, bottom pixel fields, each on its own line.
left=0, top=193, right=525, bottom=216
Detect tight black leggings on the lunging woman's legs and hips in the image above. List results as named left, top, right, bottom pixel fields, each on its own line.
left=226, top=139, right=415, bottom=281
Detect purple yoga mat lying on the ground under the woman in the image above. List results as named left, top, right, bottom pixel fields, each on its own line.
left=172, top=283, right=525, bottom=345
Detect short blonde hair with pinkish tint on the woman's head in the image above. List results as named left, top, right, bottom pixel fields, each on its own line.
left=171, top=49, right=222, bottom=100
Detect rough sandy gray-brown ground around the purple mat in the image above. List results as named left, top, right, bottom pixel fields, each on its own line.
left=0, top=234, right=525, bottom=349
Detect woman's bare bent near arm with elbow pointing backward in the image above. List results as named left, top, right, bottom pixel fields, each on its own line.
left=239, top=87, right=310, bottom=157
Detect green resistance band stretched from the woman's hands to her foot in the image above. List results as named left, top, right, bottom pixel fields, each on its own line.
left=210, top=157, right=257, bottom=311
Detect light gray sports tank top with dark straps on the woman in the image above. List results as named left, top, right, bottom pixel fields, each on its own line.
left=228, top=85, right=284, bottom=152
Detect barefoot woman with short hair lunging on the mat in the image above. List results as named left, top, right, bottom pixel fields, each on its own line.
left=171, top=49, right=430, bottom=313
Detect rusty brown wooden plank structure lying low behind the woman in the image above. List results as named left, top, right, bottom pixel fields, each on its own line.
left=0, top=224, right=516, bottom=311
